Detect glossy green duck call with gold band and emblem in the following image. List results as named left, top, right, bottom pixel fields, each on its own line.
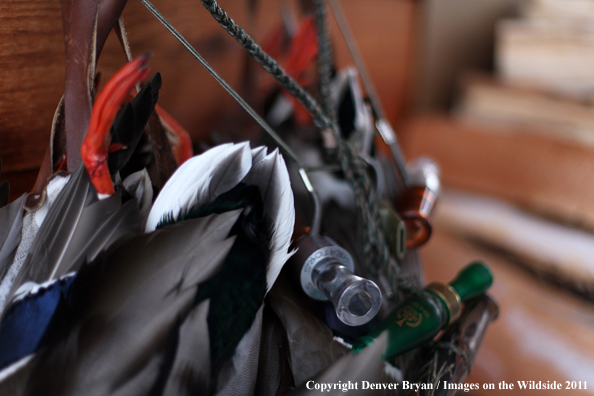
left=353, top=262, right=493, bottom=360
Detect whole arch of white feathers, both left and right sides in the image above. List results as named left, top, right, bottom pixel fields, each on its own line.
left=145, top=142, right=295, bottom=291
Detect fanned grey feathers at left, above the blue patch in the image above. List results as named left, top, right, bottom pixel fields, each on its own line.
left=7, top=166, right=141, bottom=306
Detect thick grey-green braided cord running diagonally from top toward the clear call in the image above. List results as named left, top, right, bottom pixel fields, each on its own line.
left=201, top=0, right=398, bottom=282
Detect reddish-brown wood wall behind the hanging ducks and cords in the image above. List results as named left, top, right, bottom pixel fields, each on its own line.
left=0, top=0, right=417, bottom=199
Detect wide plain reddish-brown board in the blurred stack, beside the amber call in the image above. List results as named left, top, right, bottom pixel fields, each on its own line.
left=402, top=115, right=594, bottom=229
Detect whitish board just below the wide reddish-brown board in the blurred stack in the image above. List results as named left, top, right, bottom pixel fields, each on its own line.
left=433, top=190, right=594, bottom=302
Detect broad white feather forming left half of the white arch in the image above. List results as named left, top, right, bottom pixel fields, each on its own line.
left=145, top=142, right=252, bottom=232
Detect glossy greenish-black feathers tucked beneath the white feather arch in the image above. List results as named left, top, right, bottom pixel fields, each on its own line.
left=157, top=183, right=272, bottom=376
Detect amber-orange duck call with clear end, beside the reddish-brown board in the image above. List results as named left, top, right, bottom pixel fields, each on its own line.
left=397, top=157, right=440, bottom=249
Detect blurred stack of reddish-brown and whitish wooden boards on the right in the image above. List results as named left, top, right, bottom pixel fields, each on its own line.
left=401, top=0, right=594, bottom=395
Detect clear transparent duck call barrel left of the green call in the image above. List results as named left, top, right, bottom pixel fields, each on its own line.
left=291, top=235, right=382, bottom=326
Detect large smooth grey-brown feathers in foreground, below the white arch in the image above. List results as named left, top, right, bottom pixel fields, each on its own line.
left=0, top=211, right=241, bottom=395
